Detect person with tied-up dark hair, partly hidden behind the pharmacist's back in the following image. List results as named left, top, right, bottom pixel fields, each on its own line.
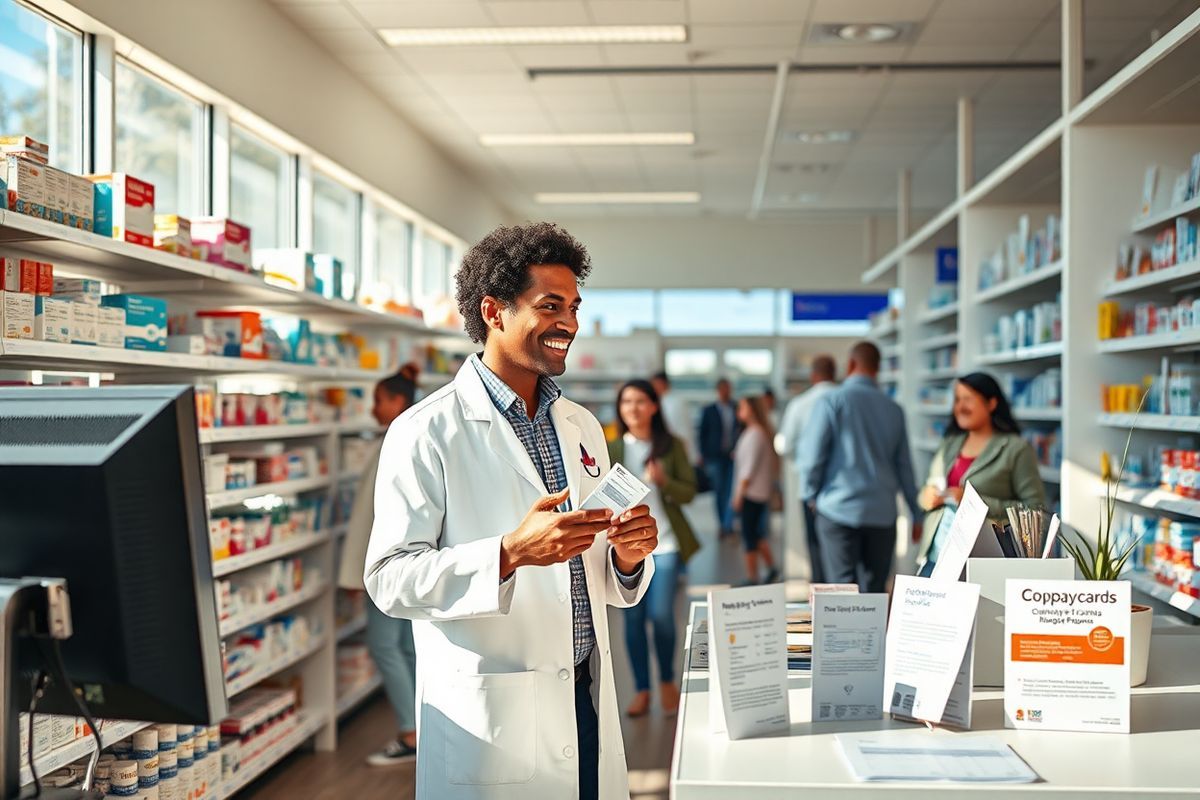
left=337, top=363, right=418, bottom=766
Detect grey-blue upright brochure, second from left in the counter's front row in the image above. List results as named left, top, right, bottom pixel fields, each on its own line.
left=812, top=594, right=888, bottom=722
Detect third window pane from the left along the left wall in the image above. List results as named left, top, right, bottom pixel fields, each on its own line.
left=229, top=125, right=294, bottom=247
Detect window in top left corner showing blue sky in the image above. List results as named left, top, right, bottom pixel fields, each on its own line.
left=0, top=0, right=83, bottom=173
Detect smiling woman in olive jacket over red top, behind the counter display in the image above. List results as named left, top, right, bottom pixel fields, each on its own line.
left=918, top=372, right=1046, bottom=575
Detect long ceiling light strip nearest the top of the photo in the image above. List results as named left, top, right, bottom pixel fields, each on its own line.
left=379, top=25, right=688, bottom=47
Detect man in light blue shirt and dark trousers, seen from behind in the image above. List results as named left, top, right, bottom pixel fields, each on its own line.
left=799, top=342, right=920, bottom=593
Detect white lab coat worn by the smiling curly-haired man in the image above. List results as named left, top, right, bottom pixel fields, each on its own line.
left=365, top=363, right=654, bottom=800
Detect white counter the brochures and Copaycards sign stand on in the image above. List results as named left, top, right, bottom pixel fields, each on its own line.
left=671, top=603, right=1200, bottom=800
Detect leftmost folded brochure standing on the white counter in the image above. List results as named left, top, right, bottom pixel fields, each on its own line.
left=708, top=583, right=791, bottom=739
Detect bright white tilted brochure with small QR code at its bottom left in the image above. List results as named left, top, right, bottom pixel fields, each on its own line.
left=883, top=575, right=979, bottom=726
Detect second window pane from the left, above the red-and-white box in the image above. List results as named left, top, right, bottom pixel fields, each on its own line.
left=114, top=61, right=205, bottom=217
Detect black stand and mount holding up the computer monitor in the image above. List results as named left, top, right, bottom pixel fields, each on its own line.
left=0, top=578, right=103, bottom=800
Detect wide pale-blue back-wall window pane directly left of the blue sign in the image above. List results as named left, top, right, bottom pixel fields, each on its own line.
left=659, top=289, right=775, bottom=336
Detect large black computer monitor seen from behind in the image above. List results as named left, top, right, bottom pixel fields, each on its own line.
left=0, top=386, right=227, bottom=724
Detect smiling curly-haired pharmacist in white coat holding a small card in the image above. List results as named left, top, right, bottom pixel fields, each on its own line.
left=365, top=223, right=658, bottom=800
